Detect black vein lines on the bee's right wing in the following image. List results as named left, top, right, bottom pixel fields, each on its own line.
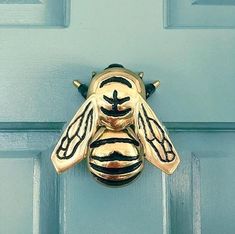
left=138, top=104, right=176, bottom=162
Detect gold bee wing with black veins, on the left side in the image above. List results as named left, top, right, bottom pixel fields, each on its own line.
left=51, top=95, right=98, bottom=173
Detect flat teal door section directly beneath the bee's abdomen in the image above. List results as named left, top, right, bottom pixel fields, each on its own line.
left=61, top=162, right=163, bottom=234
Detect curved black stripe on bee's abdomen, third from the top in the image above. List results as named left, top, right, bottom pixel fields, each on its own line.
left=90, top=161, right=142, bottom=175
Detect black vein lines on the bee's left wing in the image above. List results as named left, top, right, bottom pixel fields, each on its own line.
left=56, top=102, right=93, bottom=159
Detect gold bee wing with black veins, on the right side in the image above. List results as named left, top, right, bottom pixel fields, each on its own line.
left=135, top=96, right=180, bottom=174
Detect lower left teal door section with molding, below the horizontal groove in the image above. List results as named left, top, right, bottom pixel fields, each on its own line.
left=0, top=129, right=59, bottom=234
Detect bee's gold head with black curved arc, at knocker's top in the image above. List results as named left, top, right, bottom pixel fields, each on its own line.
left=88, top=64, right=146, bottom=98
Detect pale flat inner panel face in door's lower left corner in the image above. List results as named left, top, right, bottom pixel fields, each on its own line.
left=0, top=152, right=34, bottom=233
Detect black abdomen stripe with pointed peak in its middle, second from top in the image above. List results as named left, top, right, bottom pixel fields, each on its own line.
left=91, top=151, right=139, bottom=162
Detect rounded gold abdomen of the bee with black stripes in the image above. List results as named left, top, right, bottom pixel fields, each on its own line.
left=88, top=130, right=144, bottom=186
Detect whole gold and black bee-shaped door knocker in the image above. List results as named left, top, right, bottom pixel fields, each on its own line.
left=51, top=64, right=180, bottom=186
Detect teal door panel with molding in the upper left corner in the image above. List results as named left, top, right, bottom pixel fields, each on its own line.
left=0, top=0, right=70, bottom=27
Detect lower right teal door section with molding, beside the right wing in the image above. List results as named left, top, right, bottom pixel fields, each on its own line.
left=163, top=129, right=235, bottom=234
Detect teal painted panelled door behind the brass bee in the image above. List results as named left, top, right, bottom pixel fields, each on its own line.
left=0, top=0, right=235, bottom=234
